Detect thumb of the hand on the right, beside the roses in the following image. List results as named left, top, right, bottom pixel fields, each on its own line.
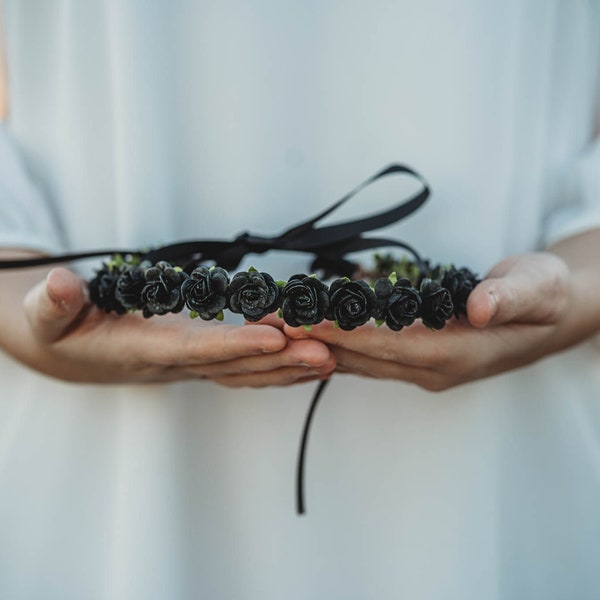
left=467, top=253, right=569, bottom=328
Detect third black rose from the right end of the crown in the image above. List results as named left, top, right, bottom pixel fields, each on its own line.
left=373, top=277, right=421, bottom=331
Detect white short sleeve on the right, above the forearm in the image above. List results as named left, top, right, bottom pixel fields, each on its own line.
left=544, top=137, right=600, bottom=247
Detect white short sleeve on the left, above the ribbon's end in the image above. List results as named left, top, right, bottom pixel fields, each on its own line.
left=0, top=123, right=64, bottom=253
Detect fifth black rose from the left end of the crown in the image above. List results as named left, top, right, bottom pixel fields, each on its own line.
left=229, top=270, right=280, bottom=321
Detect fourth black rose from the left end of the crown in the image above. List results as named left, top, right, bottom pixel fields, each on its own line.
left=181, top=267, right=229, bottom=321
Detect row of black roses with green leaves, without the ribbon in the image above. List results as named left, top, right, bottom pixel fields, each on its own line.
left=90, top=254, right=478, bottom=331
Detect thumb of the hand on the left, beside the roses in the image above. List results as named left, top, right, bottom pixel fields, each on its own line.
left=24, top=268, right=88, bottom=343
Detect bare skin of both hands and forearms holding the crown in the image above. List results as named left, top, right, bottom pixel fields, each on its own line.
left=0, top=15, right=600, bottom=391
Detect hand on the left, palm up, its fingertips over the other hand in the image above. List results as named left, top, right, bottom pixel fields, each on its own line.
left=0, top=268, right=335, bottom=387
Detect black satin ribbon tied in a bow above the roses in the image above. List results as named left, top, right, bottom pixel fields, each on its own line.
left=0, top=164, right=430, bottom=276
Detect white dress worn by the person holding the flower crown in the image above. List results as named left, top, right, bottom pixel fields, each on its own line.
left=0, top=0, right=600, bottom=600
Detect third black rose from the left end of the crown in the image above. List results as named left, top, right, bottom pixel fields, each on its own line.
left=142, top=261, right=187, bottom=317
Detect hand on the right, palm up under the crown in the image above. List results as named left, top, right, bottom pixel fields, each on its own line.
left=284, top=253, right=600, bottom=391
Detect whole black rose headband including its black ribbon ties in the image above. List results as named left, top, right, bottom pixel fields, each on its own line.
left=0, top=164, right=479, bottom=514
